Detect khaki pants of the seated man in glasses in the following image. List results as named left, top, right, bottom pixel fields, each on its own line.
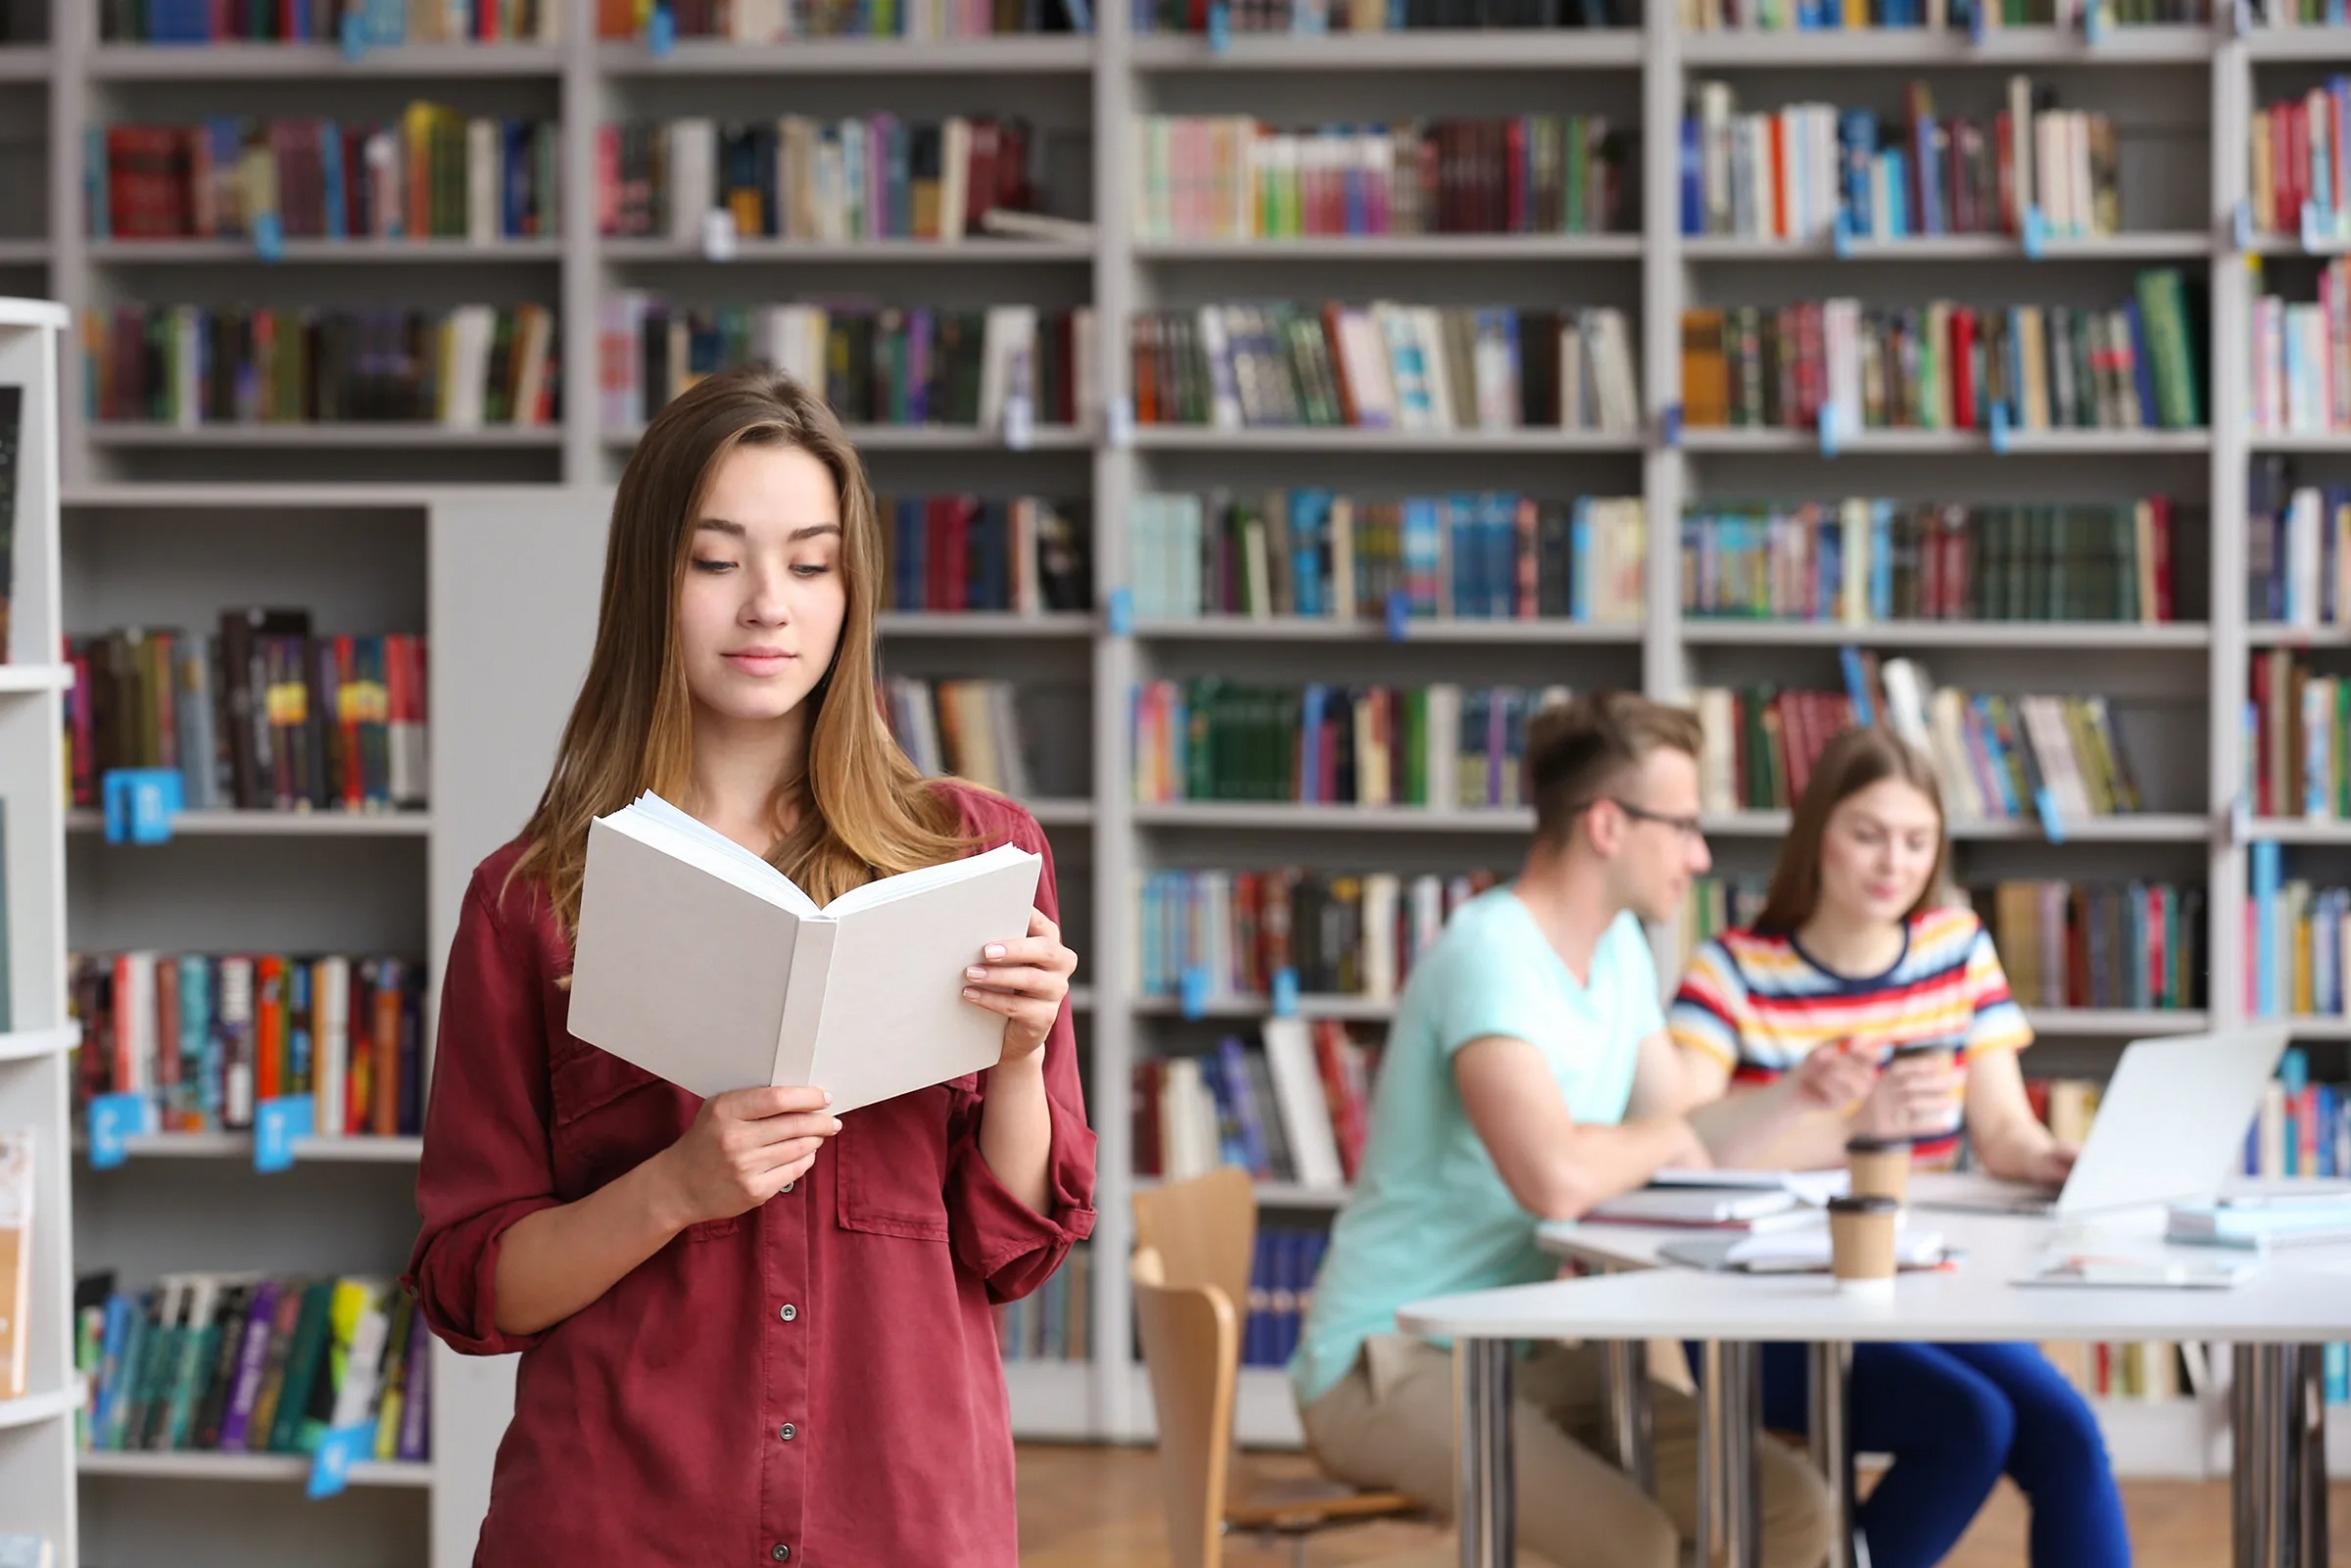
left=1302, top=1335, right=1829, bottom=1568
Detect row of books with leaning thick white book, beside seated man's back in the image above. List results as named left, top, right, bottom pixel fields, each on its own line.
left=1133, top=1018, right=1378, bottom=1192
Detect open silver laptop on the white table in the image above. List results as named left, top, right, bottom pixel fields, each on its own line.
left=1911, top=1025, right=2288, bottom=1215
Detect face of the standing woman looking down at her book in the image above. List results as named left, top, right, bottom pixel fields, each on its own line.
left=677, top=447, right=849, bottom=722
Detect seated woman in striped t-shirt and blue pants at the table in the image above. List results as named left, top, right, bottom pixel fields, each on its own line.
left=1669, top=729, right=2130, bottom=1568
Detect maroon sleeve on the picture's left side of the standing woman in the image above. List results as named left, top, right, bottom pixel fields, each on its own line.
left=404, top=872, right=560, bottom=1356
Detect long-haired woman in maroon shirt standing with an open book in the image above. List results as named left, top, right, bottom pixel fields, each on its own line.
left=409, top=371, right=1093, bottom=1568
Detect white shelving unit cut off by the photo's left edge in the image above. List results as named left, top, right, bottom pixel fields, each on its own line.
left=0, top=299, right=80, bottom=1568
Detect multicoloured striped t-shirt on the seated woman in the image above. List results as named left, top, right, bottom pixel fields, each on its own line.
left=1667, top=907, right=2034, bottom=1161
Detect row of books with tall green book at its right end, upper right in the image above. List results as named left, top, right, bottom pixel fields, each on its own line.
left=1681, top=268, right=2205, bottom=435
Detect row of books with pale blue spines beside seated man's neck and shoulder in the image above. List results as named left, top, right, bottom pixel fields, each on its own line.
left=1133, top=865, right=1495, bottom=1009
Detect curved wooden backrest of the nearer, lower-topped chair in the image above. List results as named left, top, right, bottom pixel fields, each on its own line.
left=1128, top=1246, right=1241, bottom=1568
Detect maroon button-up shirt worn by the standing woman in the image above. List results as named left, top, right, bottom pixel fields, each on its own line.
left=407, top=785, right=1093, bottom=1568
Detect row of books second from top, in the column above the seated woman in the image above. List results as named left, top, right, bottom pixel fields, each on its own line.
left=1681, top=75, right=2121, bottom=240
